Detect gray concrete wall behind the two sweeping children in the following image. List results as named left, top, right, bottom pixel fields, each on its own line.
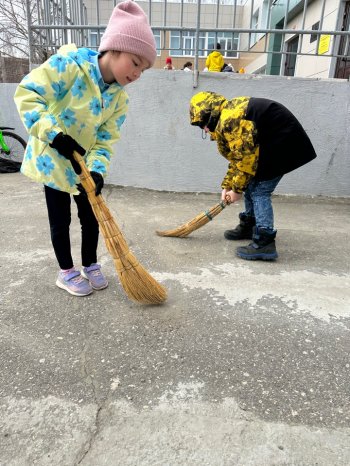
left=0, top=70, right=350, bottom=197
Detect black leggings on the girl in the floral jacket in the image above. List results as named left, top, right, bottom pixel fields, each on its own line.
left=44, top=186, right=98, bottom=269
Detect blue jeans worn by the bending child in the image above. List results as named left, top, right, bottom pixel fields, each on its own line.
left=244, top=176, right=282, bottom=233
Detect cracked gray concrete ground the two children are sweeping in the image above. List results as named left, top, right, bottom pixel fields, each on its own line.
left=0, top=174, right=350, bottom=466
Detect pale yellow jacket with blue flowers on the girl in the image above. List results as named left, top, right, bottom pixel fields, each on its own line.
left=14, top=44, right=128, bottom=194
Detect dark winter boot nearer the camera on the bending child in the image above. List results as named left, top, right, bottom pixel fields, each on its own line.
left=237, top=227, right=278, bottom=261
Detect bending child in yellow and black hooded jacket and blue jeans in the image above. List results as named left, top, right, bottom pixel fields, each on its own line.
left=190, top=92, right=316, bottom=260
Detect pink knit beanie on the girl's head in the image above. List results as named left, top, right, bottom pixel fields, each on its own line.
left=98, top=0, right=157, bottom=66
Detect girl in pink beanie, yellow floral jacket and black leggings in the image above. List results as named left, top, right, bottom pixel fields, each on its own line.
left=15, top=0, right=156, bottom=296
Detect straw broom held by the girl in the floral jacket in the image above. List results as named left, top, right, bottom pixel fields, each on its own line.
left=73, top=151, right=167, bottom=304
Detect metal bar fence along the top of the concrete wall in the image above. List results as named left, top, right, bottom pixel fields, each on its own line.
left=26, top=0, right=350, bottom=79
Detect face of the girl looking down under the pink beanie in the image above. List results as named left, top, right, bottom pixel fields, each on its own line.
left=99, top=51, right=149, bottom=86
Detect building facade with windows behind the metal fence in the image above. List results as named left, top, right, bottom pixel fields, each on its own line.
left=85, top=0, right=350, bottom=79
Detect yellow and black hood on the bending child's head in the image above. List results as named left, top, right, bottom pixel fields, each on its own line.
left=190, top=92, right=227, bottom=132
